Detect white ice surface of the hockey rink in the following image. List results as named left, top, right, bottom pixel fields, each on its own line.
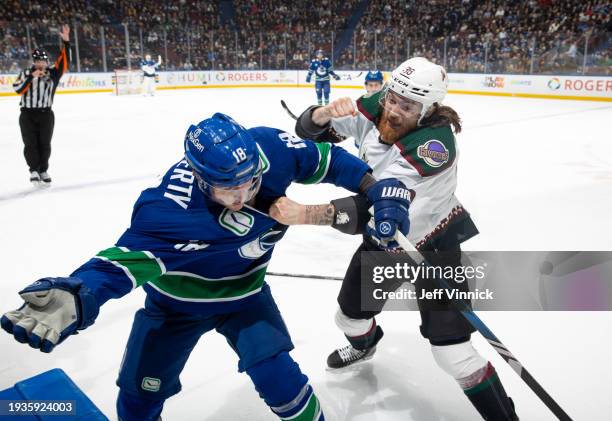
left=0, top=89, right=612, bottom=421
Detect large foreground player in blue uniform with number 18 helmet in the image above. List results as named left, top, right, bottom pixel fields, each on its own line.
left=0, top=113, right=408, bottom=421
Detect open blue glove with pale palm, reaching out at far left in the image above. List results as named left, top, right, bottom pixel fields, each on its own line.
left=0, top=278, right=99, bottom=352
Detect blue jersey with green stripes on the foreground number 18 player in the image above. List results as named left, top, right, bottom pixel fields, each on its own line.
left=72, top=127, right=370, bottom=314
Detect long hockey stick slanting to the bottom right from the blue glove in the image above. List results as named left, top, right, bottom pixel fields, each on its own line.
left=395, top=231, right=572, bottom=421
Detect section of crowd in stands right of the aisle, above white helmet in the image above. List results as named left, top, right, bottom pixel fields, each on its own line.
left=357, top=0, right=612, bottom=73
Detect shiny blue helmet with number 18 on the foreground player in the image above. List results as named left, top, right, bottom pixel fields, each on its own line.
left=185, top=113, right=261, bottom=195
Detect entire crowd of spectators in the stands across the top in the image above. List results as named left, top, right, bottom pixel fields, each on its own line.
left=0, top=0, right=612, bottom=74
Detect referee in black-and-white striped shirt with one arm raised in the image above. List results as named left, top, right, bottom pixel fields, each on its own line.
left=13, top=25, right=70, bottom=185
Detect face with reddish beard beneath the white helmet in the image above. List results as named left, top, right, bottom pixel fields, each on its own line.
left=377, top=91, right=423, bottom=145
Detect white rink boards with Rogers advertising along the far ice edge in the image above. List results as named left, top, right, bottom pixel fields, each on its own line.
left=0, top=70, right=612, bottom=102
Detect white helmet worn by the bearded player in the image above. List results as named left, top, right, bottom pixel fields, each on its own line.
left=387, top=57, right=448, bottom=124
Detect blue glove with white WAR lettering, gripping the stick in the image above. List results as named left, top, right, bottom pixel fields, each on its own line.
left=366, top=178, right=411, bottom=249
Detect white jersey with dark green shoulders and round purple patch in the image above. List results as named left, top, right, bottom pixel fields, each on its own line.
left=331, top=93, right=466, bottom=248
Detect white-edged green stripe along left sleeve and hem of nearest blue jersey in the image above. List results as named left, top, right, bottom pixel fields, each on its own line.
left=96, top=247, right=268, bottom=302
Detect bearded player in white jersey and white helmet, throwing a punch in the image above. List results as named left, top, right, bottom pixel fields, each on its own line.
left=276, top=57, right=518, bottom=421
